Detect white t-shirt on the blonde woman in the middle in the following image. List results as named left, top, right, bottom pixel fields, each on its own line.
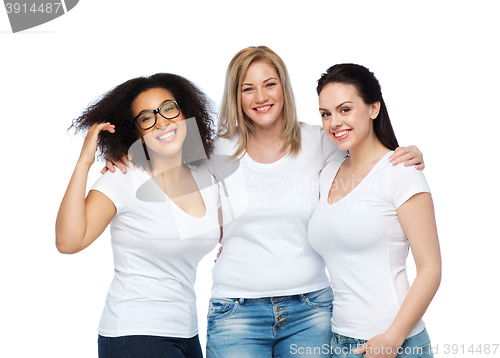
left=212, top=124, right=345, bottom=298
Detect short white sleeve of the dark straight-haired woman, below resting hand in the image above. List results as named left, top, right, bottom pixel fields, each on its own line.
left=386, top=164, right=431, bottom=209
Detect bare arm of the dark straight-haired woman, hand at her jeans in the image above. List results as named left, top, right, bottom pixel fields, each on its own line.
left=357, top=193, right=441, bottom=358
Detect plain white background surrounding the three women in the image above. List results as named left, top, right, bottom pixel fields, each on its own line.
left=0, top=0, right=500, bottom=358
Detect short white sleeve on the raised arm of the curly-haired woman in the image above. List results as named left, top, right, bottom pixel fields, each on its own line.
left=90, top=169, right=133, bottom=215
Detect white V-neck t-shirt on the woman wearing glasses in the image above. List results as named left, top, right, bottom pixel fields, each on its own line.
left=92, top=167, right=220, bottom=338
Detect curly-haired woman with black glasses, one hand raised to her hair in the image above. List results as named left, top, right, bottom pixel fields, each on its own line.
left=56, top=74, right=220, bottom=358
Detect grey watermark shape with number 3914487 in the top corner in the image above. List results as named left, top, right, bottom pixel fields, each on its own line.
left=4, top=0, right=79, bottom=33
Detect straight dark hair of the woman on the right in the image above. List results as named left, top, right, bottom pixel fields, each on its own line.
left=316, top=63, right=399, bottom=150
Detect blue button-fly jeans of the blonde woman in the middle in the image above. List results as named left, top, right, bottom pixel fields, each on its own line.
left=207, top=287, right=333, bottom=358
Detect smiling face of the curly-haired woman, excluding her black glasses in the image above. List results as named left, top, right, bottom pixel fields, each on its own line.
left=132, top=88, right=186, bottom=160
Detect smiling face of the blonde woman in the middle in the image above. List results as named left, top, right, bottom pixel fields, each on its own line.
left=241, top=61, right=284, bottom=129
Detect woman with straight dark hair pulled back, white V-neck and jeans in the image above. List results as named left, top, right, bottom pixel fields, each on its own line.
left=308, top=64, right=441, bottom=358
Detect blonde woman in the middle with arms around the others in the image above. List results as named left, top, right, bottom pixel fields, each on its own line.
left=207, top=46, right=422, bottom=358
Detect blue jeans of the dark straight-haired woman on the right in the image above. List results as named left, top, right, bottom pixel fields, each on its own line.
left=331, top=328, right=434, bottom=358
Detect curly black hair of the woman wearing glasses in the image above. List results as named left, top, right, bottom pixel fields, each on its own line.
left=68, top=73, right=215, bottom=168
